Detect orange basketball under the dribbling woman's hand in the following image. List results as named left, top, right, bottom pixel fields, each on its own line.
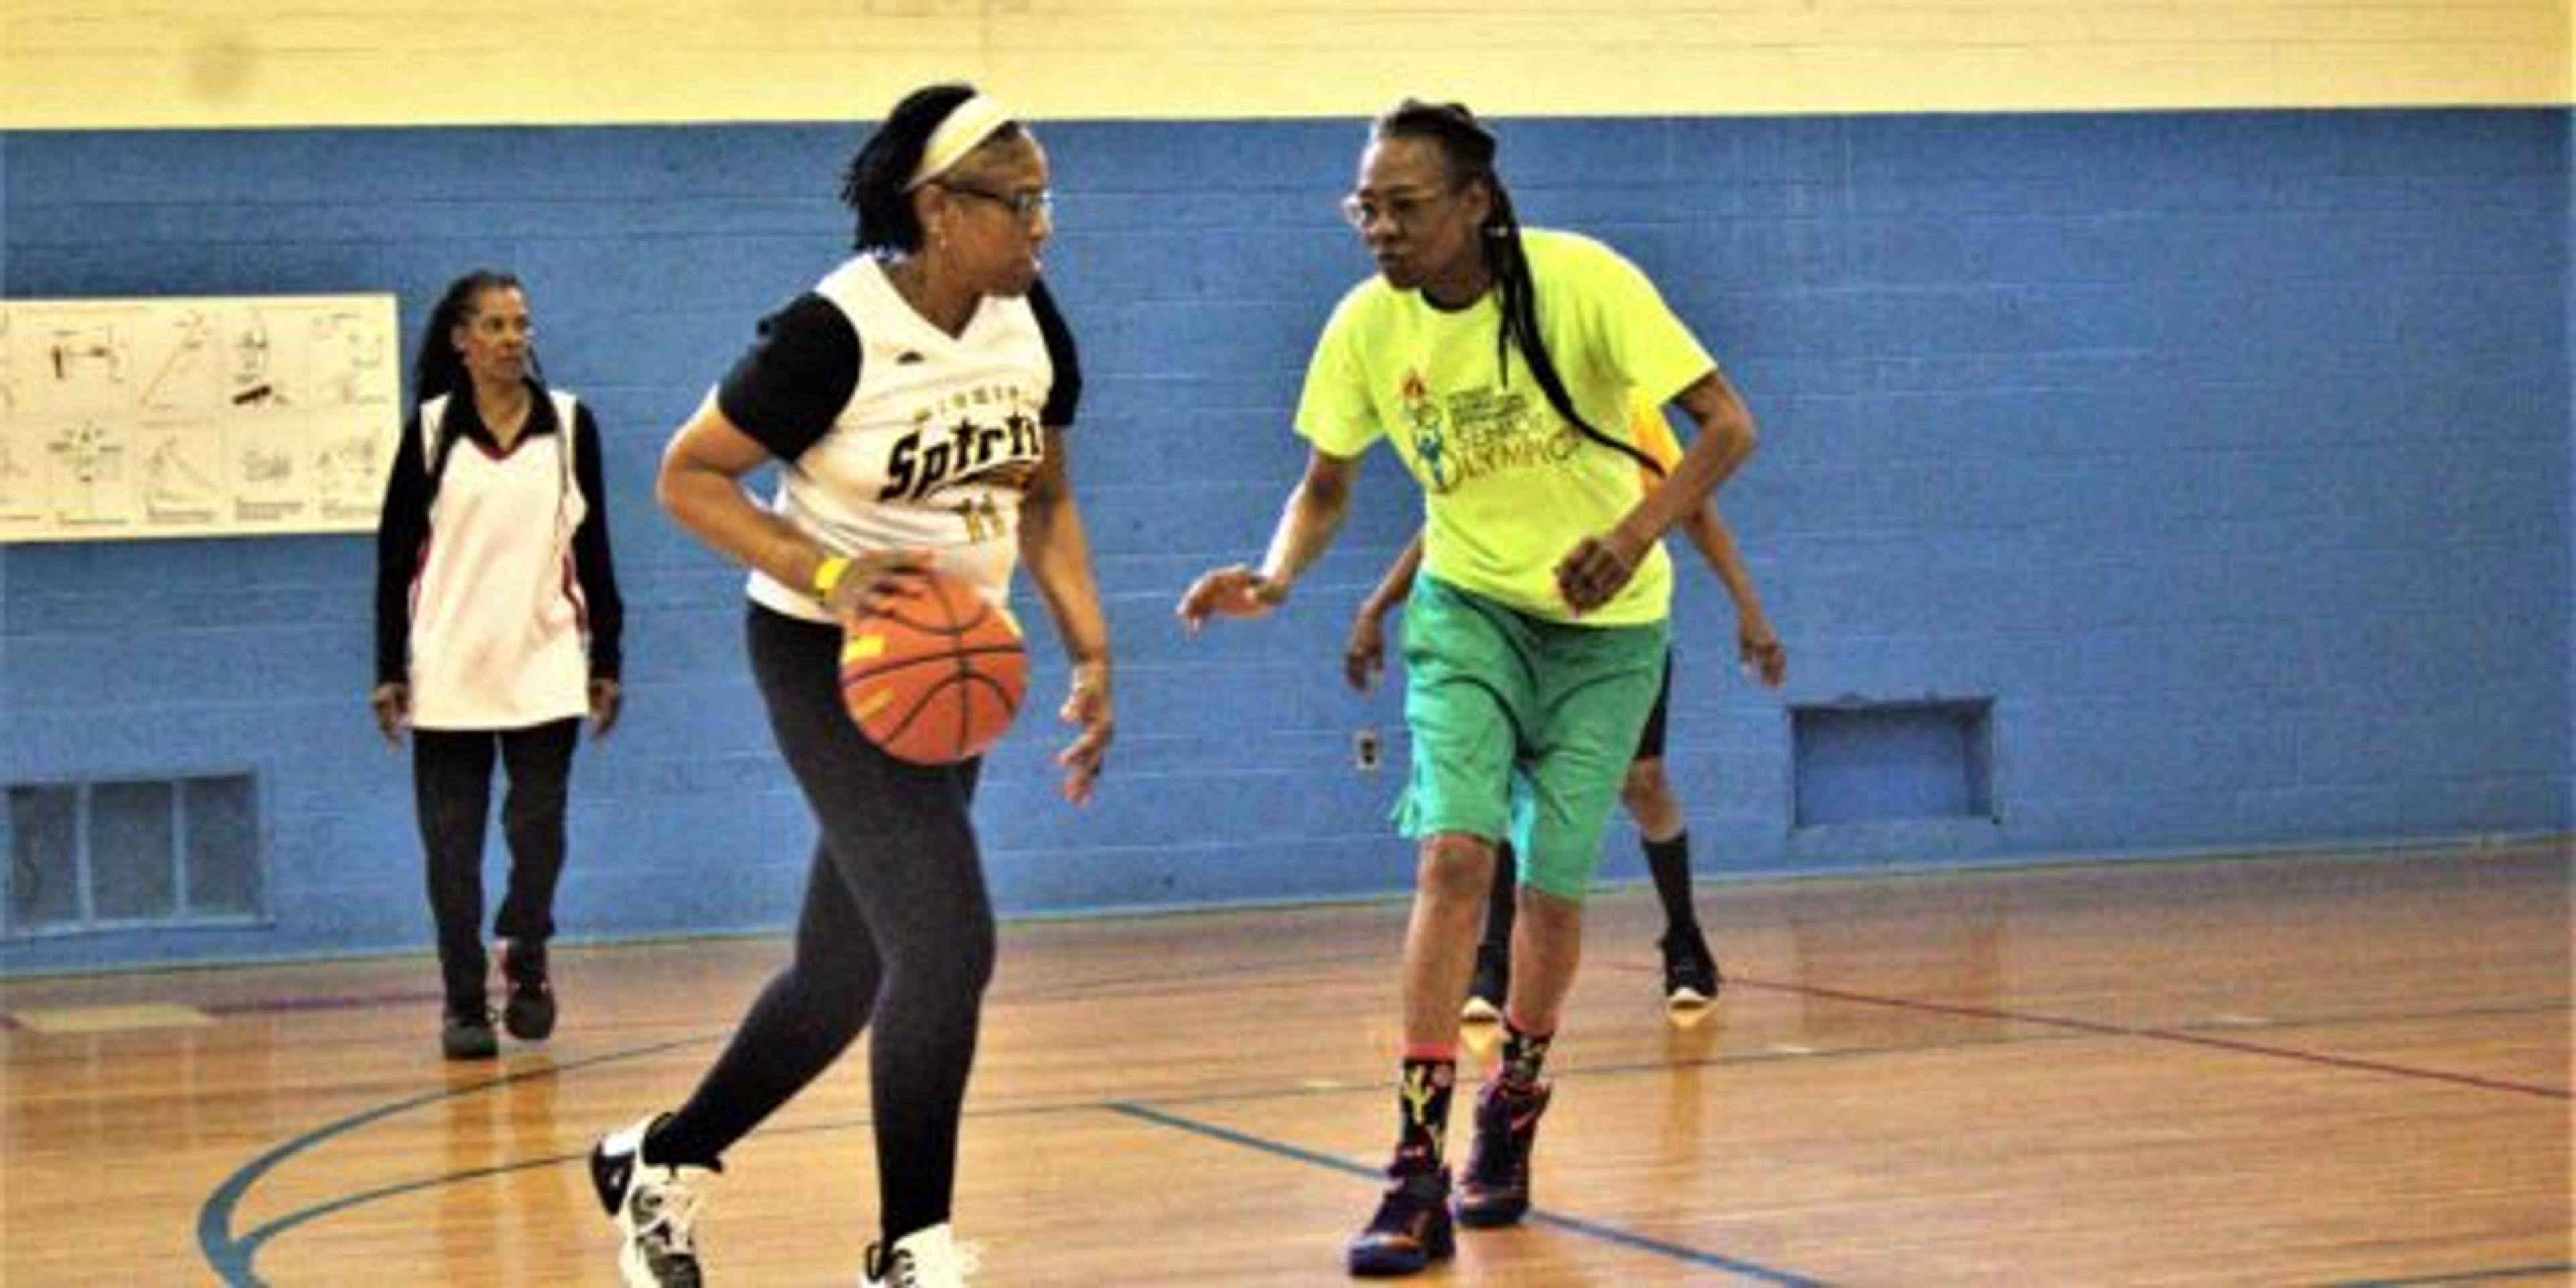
left=840, top=574, right=1028, bottom=765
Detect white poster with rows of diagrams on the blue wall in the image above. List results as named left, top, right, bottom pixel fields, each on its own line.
left=0, top=297, right=402, bottom=543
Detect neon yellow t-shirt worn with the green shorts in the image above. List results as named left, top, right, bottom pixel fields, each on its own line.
left=1296, top=229, right=1715, bottom=626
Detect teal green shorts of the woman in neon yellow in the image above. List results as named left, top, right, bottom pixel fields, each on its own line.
left=1396, top=577, right=1666, bottom=902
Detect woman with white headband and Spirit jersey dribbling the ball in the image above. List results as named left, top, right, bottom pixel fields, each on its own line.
left=590, top=85, right=1113, bottom=1285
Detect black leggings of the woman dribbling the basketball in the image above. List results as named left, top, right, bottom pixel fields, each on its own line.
left=647, top=605, right=994, bottom=1244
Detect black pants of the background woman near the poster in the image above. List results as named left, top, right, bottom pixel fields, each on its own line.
left=412, top=718, right=582, bottom=1010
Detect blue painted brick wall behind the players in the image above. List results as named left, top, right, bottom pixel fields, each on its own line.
left=0, top=111, right=2576, bottom=971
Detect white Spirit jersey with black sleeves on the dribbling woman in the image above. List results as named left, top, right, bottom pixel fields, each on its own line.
left=716, top=255, right=1082, bottom=621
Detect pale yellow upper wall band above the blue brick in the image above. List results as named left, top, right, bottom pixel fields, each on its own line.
left=0, top=0, right=2576, bottom=129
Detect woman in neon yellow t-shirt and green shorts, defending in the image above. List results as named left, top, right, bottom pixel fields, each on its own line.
left=1180, top=101, right=1754, bottom=1275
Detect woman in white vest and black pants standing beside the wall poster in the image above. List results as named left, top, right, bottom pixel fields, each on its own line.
left=368, top=270, right=623, bottom=1059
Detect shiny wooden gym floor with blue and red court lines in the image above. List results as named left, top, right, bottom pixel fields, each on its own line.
left=0, top=843, right=2576, bottom=1285
